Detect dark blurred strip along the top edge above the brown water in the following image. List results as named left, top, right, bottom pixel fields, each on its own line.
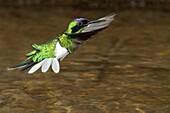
left=0, top=0, right=170, bottom=10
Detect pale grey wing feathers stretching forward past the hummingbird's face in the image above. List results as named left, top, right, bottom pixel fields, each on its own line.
left=81, top=13, right=116, bottom=33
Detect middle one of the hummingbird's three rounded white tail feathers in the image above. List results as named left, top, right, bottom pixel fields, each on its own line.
left=41, top=58, right=52, bottom=73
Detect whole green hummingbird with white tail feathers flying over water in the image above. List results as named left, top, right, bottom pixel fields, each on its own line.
left=8, top=13, right=116, bottom=74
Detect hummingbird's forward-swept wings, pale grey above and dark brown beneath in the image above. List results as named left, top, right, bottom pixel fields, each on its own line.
left=68, top=13, right=116, bottom=48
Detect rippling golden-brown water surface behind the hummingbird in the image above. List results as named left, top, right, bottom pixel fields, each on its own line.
left=0, top=9, right=170, bottom=113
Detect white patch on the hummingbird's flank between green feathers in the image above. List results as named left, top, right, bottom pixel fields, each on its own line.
left=55, top=42, right=69, bottom=60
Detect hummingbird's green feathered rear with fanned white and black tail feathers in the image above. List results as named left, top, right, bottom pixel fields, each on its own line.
left=8, top=40, right=60, bottom=74
